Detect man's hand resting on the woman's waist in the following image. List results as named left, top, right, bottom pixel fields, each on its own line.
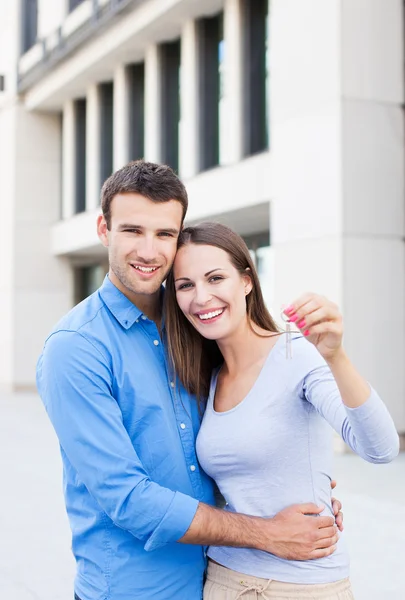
left=260, top=504, right=338, bottom=560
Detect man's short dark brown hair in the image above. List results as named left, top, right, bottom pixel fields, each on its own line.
left=101, top=160, right=188, bottom=229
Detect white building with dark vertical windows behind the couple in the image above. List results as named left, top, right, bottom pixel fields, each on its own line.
left=0, top=0, right=405, bottom=440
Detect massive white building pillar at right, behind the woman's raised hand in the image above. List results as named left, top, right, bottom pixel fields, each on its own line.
left=270, top=0, right=405, bottom=432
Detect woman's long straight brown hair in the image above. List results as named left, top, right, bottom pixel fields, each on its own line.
left=164, top=223, right=278, bottom=402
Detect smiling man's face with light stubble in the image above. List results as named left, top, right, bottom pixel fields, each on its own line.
left=98, top=193, right=183, bottom=295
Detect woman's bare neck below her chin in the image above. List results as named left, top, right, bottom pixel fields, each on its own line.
left=217, top=322, right=275, bottom=377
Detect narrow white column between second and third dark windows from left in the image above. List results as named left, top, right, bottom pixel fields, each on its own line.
left=113, top=65, right=129, bottom=171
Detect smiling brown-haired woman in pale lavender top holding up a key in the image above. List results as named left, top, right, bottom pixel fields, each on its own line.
left=165, top=223, right=399, bottom=600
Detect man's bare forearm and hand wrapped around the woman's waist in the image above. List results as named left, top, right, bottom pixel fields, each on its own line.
left=179, top=503, right=338, bottom=560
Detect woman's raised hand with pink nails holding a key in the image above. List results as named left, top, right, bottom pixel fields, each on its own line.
left=283, top=293, right=343, bottom=361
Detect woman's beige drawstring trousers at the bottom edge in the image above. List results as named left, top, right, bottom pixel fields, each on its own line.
left=204, top=560, right=354, bottom=600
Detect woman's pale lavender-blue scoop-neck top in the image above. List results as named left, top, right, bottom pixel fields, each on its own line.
left=197, top=336, right=399, bottom=584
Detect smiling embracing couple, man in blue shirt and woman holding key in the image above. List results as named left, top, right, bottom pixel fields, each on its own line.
left=37, top=161, right=398, bottom=600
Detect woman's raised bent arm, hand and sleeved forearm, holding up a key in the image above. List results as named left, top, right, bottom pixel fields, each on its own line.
left=284, top=294, right=399, bottom=462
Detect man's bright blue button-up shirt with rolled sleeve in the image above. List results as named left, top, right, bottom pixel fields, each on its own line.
left=37, top=277, right=214, bottom=600
